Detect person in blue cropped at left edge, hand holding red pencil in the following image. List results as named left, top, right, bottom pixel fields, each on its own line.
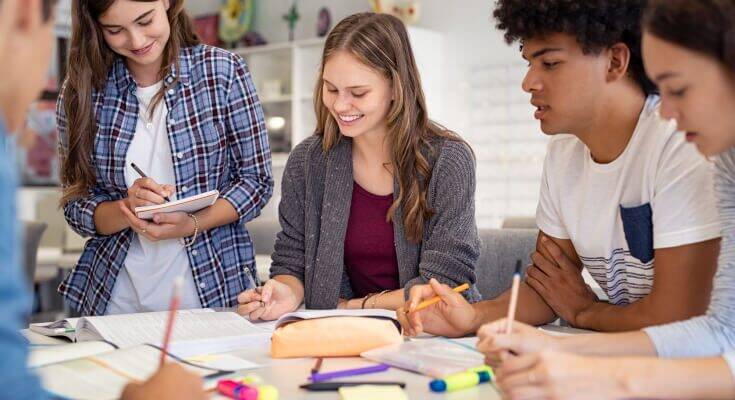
left=0, top=0, right=207, bottom=400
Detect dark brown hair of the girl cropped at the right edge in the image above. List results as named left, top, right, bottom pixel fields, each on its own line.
left=643, top=0, right=735, bottom=72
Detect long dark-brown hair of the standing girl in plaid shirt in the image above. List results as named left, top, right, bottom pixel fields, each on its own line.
left=61, top=0, right=199, bottom=205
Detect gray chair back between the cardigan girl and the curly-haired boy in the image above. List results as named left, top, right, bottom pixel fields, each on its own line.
left=476, top=229, right=538, bottom=299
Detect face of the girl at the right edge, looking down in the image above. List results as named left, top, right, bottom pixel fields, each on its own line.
left=643, top=32, right=735, bottom=156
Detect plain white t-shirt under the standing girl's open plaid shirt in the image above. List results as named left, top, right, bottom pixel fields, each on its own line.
left=105, top=82, right=201, bottom=314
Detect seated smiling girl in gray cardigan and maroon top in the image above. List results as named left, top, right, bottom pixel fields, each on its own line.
left=238, top=13, right=480, bottom=320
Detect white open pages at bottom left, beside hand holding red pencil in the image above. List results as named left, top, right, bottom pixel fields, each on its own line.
left=36, top=346, right=216, bottom=399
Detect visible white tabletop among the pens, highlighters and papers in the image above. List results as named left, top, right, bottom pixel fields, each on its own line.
left=21, top=329, right=500, bottom=400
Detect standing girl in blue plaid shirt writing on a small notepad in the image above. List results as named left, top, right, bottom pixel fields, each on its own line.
left=57, top=0, right=273, bottom=315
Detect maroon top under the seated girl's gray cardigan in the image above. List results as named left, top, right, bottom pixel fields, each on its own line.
left=345, top=182, right=400, bottom=297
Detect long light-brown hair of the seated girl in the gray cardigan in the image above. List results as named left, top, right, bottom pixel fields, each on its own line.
left=314, top=12, right=461, bottom=242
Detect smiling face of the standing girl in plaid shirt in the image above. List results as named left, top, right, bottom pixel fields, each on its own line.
left=98, top=0, right=171, bottom=73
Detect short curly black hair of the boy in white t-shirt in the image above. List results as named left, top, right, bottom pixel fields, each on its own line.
left=493, top=0, right=656, bottom=94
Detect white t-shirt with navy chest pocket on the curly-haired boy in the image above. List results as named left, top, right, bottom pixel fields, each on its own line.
left=536, top=96, right=720, bottom=305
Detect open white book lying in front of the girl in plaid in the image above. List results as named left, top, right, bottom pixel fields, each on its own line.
left=30, top=308, right=272, bottom=357
